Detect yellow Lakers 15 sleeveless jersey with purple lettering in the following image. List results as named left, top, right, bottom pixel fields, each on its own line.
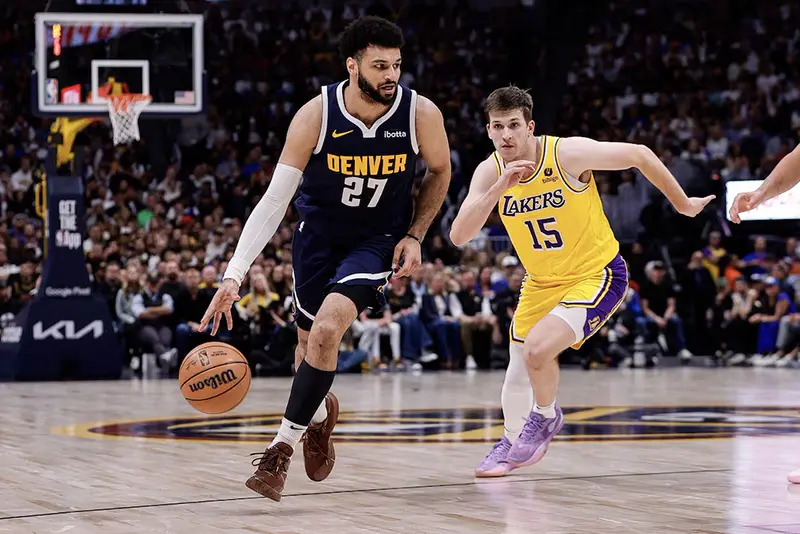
left=491, top=136, right=619, bottom=285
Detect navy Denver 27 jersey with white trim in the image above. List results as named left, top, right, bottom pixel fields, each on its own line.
left=295, top=82, right=419, bottom=238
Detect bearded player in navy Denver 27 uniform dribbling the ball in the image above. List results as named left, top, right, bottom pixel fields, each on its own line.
left=200, top=17, right=450, bottom=501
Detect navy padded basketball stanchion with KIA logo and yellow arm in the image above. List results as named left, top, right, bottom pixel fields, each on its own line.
left=0, top=118, right=122, bottom=381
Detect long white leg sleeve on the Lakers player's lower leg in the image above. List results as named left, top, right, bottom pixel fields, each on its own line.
left=500, top=343, right=533, bottom=443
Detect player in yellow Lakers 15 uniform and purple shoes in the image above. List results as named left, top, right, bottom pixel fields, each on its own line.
left=450, top=87, right=714, bottom=476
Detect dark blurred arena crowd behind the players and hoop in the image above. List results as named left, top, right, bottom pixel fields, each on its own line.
left=0, top=0, right=800, bottom=378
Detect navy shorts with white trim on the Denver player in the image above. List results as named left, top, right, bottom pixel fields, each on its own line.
left=292, top=223, right=400, bottom=330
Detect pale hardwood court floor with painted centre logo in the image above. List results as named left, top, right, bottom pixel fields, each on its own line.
left=0, top=368, right=800, bottom=534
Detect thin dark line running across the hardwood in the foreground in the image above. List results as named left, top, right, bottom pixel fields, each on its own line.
left=0, top=468, right=733, bottom=521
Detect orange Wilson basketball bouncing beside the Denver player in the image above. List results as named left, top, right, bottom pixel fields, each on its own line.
left=178, top=341, right=250, bottom=413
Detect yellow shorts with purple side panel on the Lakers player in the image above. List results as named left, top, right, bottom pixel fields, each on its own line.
left=511, top=255, right=628, bottom=349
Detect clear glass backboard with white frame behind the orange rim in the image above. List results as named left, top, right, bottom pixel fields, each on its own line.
left=32, top=12, right=206, bottom=117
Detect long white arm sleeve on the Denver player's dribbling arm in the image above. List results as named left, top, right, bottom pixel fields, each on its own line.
left=223, top=163, right=303, bottom=285
